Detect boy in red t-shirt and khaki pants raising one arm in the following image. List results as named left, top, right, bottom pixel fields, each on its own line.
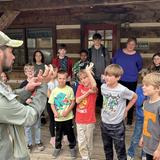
left=75, top=63, right=97, bottom=160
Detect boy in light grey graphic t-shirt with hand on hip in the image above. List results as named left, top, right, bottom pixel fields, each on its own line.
left=101, top=64, right=137, bottom=160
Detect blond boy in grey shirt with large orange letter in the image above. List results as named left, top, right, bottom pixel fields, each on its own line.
left=140, top=72, right=160, bottom=160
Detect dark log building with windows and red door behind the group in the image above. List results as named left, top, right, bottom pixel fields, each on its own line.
left=0, top=0, right=160, bottom=74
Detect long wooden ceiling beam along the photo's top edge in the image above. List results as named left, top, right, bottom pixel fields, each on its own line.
left=0, top=0, right=159, bottom=11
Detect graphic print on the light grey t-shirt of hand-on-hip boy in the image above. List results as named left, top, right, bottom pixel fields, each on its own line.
left=103, top=94, right=120, bottom=114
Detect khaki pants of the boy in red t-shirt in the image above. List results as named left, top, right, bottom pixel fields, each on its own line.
left=77, top=123, right=95, bottom=159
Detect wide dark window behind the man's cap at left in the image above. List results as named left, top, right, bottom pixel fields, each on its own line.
left=4, top=28, right=53, bottom=69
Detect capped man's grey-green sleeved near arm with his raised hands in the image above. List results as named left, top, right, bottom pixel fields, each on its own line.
left=0, top=66, right=52, bottom=126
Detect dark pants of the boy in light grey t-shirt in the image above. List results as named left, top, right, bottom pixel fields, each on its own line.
left=101, top=121, right=127, bottom=160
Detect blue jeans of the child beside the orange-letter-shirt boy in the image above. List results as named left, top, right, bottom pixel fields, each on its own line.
left=128, top=117, right=145, bottom=158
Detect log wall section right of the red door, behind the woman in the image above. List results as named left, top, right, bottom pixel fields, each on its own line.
left=120, top=23, right=160, bottom=68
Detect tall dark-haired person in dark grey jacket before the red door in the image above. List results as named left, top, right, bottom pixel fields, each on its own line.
left=88, top=33, right=110, bottom=107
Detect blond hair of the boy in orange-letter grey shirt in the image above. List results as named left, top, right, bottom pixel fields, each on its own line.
left=142, top=72, right=160, bottom=88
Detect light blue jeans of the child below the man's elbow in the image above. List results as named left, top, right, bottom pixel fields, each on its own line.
left=25, top=118, right=41, bottom=145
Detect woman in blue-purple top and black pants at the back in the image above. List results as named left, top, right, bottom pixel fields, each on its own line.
left=112, top=37, right=143, bottom=125
